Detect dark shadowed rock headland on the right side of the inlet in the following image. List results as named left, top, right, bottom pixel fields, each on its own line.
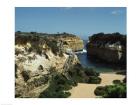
left=87, top=33, right=126, bottom=65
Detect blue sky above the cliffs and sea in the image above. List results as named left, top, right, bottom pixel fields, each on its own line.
left=15, top=7, right=126, bottom=39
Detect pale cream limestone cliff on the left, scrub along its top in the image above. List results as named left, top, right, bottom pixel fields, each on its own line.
left=15, top=32, right=81, bottom=97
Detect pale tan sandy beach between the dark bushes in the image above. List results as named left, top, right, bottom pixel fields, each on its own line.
left=70, top=73, right=125, bottom=98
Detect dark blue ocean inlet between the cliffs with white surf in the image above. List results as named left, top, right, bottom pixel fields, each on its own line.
left=76, top=40, right=119, bottom=72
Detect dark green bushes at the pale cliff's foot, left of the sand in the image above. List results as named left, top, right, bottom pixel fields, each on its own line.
left=39, top=64, right=101, bottom=98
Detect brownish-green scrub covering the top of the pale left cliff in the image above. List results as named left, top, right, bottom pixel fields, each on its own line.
left=15, top=31, right=76, bottom=57
